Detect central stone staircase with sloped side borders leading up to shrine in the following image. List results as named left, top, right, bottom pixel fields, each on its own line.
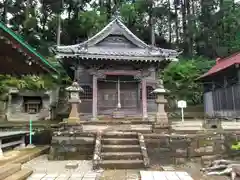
left=93, top=132, right=149, bottom=169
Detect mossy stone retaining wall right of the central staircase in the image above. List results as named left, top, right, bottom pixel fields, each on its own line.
left=144, top=132, right=240, bottom=164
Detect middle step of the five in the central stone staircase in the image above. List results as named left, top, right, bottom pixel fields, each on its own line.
left=102, top=145, right=141, bottom=152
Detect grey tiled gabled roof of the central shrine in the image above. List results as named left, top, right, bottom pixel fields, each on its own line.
left=55, top=18, right=179, bottom=60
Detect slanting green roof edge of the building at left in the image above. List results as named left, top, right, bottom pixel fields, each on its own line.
left=0, top=21, right=59, bottom=74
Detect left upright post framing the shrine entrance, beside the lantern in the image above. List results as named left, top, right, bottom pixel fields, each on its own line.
left=92, top=74, right=98, bottom=120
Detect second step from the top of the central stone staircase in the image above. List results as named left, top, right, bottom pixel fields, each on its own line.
left=102, top=138, right=139, bottom=145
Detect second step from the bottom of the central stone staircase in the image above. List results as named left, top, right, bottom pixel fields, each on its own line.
left=101, top=152, right=142, bottom=160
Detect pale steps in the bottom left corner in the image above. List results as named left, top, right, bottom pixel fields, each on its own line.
left=0, top=164, right=33, bottom=180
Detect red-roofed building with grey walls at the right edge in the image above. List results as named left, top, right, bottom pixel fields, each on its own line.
left=200, top=53, right=240, bottom=118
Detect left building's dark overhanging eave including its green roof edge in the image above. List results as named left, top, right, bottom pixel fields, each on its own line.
left=0, top=22, right=58, bottom=75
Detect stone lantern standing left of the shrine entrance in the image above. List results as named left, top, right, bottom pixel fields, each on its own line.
left=66, top=82, right=83, bottom=124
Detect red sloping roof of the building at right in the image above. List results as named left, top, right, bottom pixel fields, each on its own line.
left=199, top=52, right=240, bottom=79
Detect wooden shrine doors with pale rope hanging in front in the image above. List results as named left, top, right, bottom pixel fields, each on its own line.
left=98, top=76, right=140, bottom=114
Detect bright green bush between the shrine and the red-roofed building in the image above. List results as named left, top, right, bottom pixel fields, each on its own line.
left=163, top=57, right=214, bottom=105
